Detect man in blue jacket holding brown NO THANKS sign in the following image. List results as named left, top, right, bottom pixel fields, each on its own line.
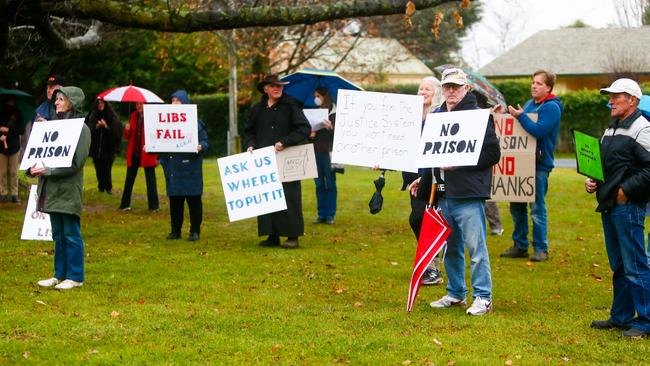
left=501, top=70, right=562, bottom=262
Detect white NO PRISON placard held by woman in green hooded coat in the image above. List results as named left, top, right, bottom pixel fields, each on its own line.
left=20, top=118, right=84, bottom=170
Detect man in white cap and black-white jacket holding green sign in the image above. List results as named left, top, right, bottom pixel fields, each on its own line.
left=585, top=79, right=650, bottom=338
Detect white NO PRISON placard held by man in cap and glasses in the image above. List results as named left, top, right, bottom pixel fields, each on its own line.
left=416, top=109, right=490, bottom=168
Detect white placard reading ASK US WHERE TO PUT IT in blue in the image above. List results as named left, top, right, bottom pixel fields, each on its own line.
left=217, top=146, right=287, bottom=222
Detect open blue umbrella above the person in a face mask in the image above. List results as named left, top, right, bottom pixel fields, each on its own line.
left=281, top=69, right=363, bottom=107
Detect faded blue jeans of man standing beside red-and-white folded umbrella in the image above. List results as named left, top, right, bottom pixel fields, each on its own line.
left=439, top=198, right=492, bottom=300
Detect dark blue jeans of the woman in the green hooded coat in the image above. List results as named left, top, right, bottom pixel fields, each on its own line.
left=50, top=213, right=84, bottom=282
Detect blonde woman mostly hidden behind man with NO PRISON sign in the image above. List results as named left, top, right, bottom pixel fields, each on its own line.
left=402, top=76, right=444, bottom=285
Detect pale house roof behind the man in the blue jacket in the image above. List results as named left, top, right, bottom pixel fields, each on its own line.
left=478, top=27, right=650, bottom=77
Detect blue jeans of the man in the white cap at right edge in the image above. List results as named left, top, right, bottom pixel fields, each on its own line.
left=602, top=203, right=650, bottom=332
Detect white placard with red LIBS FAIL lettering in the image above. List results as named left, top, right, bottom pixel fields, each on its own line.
left=143, top=104, right=199, bottom=153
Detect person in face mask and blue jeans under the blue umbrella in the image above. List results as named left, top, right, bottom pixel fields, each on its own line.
left=309, top=88, right=337, bottom=224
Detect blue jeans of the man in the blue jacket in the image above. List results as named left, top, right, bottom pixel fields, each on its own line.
left=510, top=170, right=548, bottom=253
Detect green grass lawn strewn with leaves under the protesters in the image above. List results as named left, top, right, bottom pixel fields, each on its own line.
left=0, top=159, right=650, bottom=365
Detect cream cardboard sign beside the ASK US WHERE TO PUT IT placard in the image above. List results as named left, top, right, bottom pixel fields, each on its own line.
left=275, top=144, right=318, bottom=183
